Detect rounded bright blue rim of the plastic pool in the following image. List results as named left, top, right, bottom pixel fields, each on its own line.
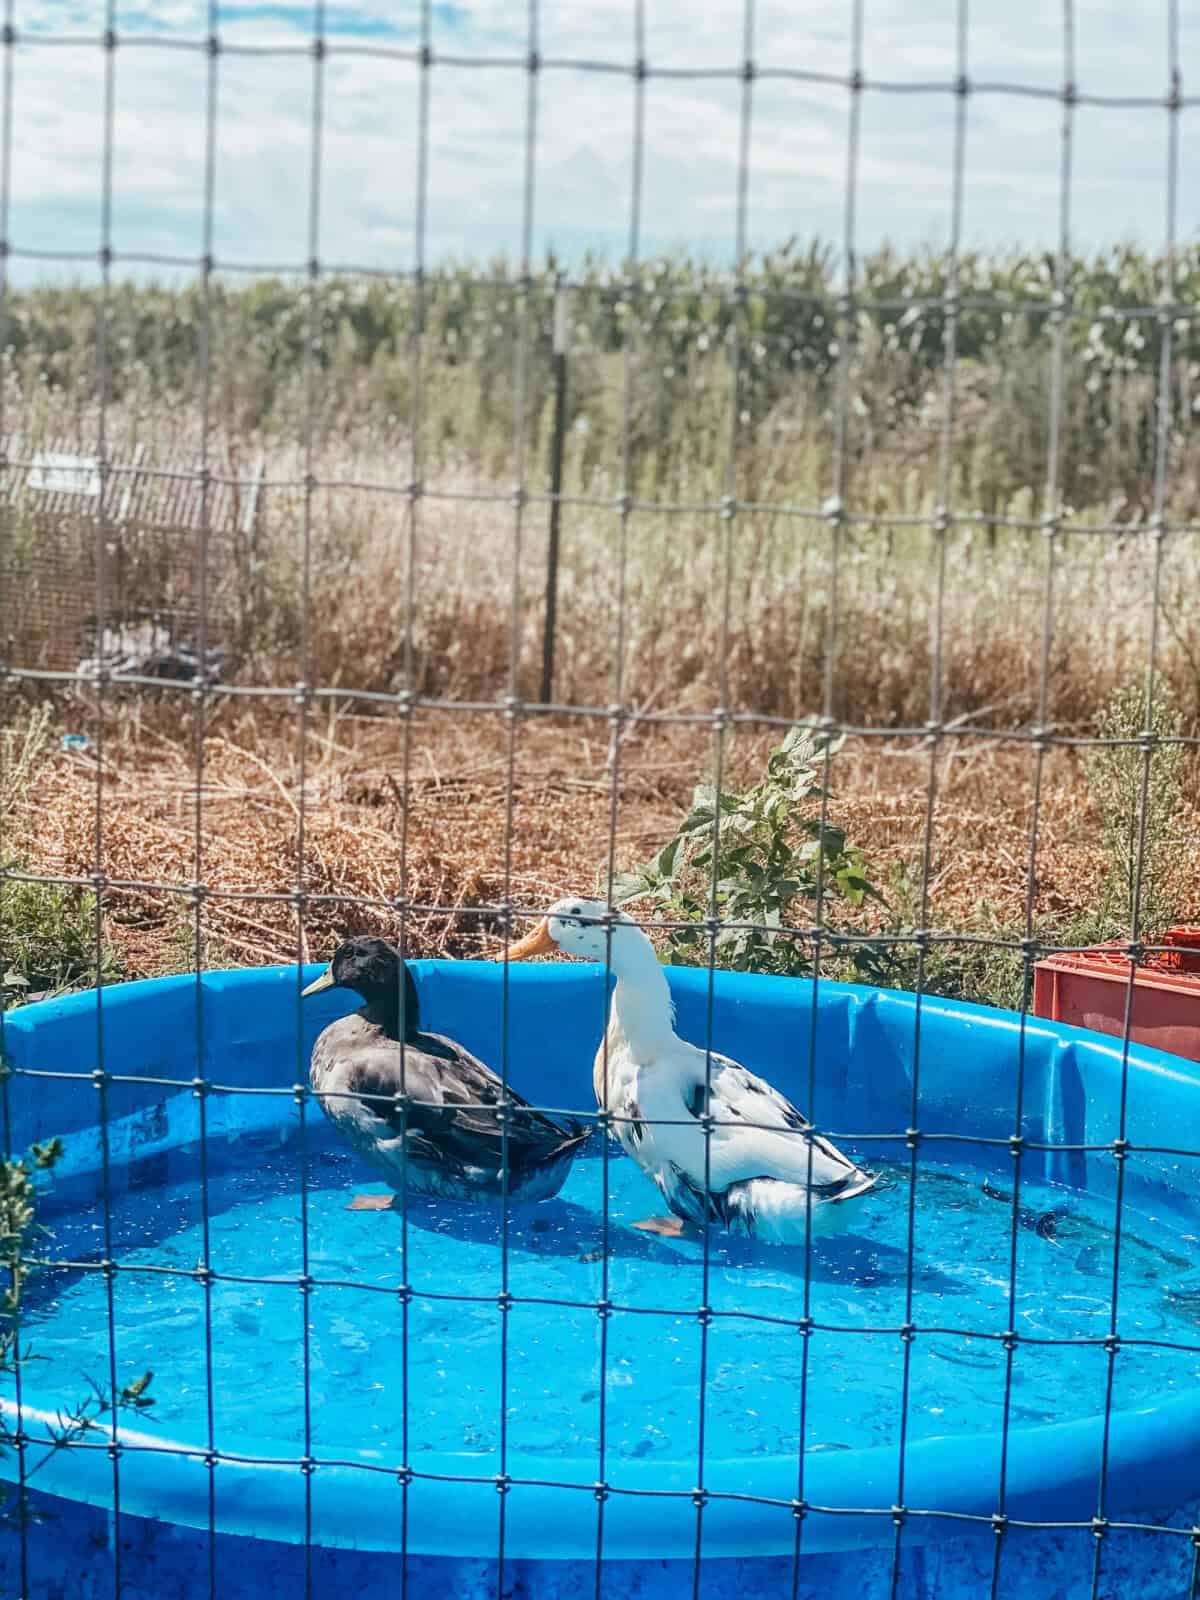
left=0, top=962, right=1200, bottom=1558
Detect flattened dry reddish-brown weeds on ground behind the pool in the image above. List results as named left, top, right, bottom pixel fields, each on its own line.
left=21, top=698, right=1200, bottom=976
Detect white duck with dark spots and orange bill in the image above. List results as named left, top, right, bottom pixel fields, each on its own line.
left=509, top=899, right=878, bottom=1245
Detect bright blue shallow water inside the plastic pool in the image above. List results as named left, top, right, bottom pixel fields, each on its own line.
left=11, top=1125, right=1200, bottom=1478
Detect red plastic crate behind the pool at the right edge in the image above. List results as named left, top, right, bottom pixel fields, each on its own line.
left=1034, top=928, right=1200, bottom=1061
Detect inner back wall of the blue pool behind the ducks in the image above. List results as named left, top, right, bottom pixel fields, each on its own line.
left=3, top=962, right=1200, bottom=1205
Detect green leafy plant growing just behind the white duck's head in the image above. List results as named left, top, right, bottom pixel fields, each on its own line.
left=613, top=725, right=880, bottom=976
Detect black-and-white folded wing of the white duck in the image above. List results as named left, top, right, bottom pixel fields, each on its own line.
left=688, top=1051, right=867, bottom=1198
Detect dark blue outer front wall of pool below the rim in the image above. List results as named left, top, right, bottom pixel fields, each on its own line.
left=0, top=1472, right=1195, bottom=1600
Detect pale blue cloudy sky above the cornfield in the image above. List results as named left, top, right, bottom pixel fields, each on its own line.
left=8, top=0, right=1200, bottom=282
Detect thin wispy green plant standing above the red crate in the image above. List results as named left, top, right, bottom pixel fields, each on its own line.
left=1085, top=683, right=1186, bottom=938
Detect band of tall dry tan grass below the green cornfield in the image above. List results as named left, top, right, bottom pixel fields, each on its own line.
left=243, top=441, right=1200, bottom=731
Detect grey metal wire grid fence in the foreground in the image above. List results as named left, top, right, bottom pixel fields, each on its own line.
left=0, top=9, right=1200, bottom=1600
